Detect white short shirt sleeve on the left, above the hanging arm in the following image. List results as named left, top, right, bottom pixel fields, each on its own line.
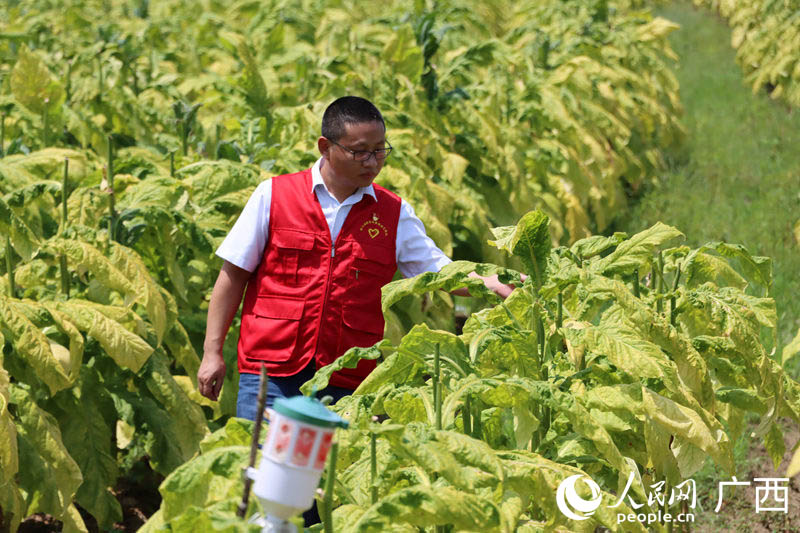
left=216, top=180, right=272, bottom=272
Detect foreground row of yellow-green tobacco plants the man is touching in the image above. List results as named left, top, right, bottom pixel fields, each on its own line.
left=141, top=211, right=800, bottom=532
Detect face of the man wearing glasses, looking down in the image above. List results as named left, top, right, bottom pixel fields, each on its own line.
left=320, top=121, right=386, bottom=191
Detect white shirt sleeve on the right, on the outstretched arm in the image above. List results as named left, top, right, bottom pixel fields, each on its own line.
left=396, top=200, right=452, bottom=278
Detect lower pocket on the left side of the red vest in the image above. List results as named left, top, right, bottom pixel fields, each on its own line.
left=240, top=296, right=305, bottom=363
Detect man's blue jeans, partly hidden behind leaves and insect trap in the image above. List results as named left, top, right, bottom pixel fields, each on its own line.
left=236, top=361, right=353, bottom=420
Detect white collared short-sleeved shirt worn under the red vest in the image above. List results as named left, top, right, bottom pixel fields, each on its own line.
left=216, top=158, right=451, bottom=278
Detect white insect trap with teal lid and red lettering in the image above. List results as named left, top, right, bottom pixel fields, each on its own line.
left=246, top=396, right=348, bottom=533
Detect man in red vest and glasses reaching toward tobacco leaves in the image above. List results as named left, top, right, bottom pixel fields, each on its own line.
left=197, top=96, right=513, bottom=420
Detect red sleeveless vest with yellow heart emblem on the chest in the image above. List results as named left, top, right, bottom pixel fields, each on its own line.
left=239, top=170, right=400, bottom=389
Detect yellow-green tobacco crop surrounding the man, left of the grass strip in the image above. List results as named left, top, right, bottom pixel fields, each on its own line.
left=0, top=0, right=800, bottom=533
